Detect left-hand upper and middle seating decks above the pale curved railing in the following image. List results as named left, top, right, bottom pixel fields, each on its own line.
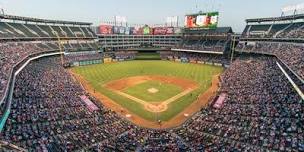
left=0, top=16, right=99, bottom=110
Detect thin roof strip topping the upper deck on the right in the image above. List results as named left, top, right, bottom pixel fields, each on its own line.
left=246, top=14, right=304, bottom=23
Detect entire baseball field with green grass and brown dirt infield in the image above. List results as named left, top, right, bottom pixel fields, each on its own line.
left=71, top=60, right=223, bottom=126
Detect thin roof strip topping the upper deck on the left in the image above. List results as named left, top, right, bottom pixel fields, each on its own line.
left=0, top=14, right=92, bottom=26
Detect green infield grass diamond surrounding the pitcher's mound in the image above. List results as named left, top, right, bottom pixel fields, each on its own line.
left=123, top=80, right=183, bottom=102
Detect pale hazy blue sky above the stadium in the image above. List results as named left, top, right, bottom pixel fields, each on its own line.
left=0, top=0, right=304, bottom=32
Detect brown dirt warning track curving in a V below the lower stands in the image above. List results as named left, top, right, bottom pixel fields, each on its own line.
left=69, top=70, right=219, bottom=129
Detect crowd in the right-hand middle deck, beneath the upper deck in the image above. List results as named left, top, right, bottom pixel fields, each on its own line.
left=237, top=42, right=304, bottom=78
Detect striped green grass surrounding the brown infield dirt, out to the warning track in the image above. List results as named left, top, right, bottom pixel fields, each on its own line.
left=72, top=60, right=223, bottom=121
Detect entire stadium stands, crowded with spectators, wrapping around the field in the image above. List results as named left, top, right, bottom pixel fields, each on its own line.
left=0, top=10, right=304, bottom=151
